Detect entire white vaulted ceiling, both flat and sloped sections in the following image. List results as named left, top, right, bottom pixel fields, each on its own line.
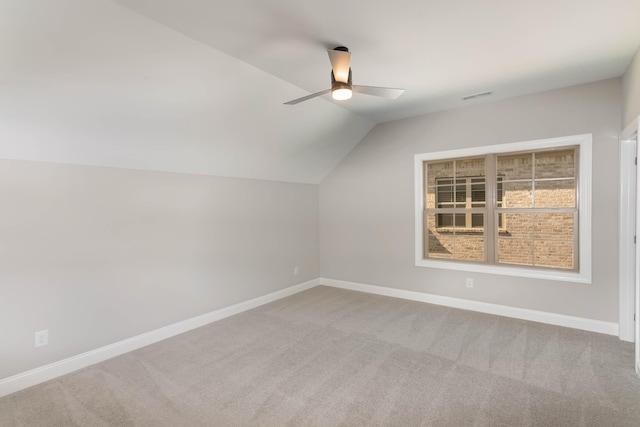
left=0, top=0, right=640, bottom=183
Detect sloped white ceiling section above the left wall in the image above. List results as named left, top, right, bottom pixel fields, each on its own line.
left=0, top=0, right=374, bottom=183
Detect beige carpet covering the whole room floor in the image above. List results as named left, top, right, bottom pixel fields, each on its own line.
left=0, top=286, right=640, bottom=426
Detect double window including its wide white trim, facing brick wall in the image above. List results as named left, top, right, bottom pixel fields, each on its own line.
left=416, top=135, right=591, bottom=282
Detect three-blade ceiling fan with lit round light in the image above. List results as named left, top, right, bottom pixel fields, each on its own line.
left=284, top=46, right=404, bottom=105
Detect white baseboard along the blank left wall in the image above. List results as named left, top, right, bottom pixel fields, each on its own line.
left=0, top=279, right=320, bottom=397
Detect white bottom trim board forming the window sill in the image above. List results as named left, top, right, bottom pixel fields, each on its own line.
left=416, top=259, right=591, bottom=284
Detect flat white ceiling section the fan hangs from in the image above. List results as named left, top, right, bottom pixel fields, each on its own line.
left=115, top=0, right=640, bottom=122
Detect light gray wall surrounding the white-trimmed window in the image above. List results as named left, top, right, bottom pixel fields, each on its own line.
left=320, top=79, right=622, bottom=322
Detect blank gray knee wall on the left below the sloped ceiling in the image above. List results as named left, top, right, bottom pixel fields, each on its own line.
left=0, top=160, right=319, bottom=379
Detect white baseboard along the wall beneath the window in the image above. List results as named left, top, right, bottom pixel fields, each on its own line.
left=320, top=278, right=619, bottom=336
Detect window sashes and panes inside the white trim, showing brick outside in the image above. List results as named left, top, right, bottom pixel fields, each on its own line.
left=423, top=147, right=578, bottom=271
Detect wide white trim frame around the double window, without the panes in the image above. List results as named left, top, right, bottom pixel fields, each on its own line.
left=414, top=134, right=592, bottom=283
